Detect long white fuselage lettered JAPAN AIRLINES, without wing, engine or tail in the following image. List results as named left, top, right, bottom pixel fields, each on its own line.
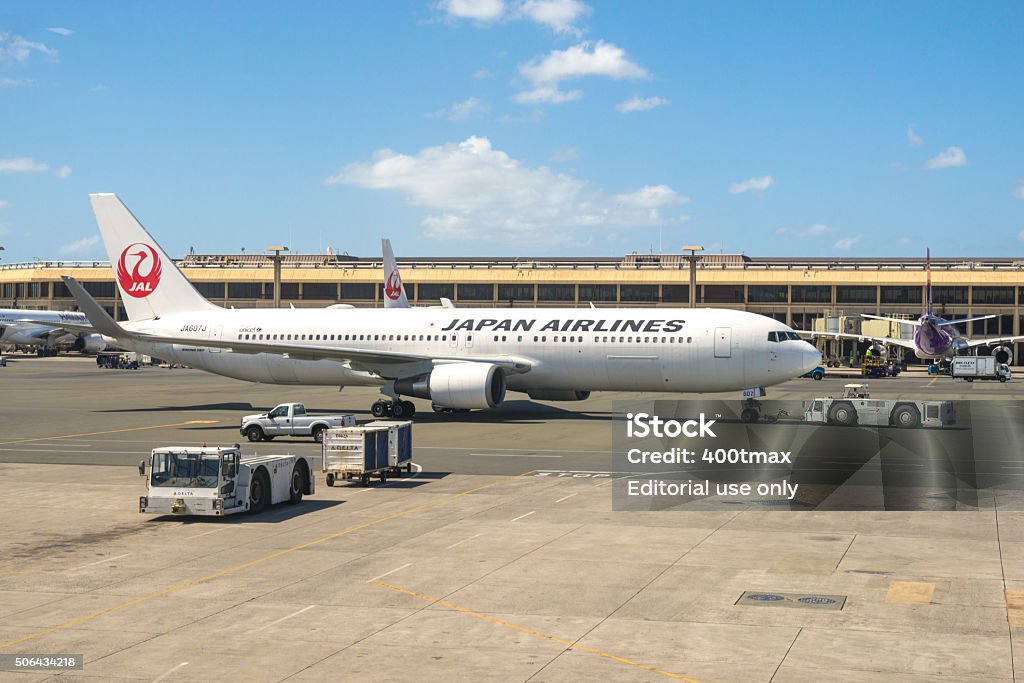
left=114, top=308, right=820, bottom=392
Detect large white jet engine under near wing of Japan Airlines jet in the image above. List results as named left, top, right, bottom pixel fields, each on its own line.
left=394, top=362, right=506, bottom=409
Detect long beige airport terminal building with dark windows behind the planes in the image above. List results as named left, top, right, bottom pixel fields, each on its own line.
left=0, top=254, right=1024, bottom=358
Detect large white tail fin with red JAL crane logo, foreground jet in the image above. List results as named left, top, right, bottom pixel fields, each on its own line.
left=89, top=194, right=217, bottom=321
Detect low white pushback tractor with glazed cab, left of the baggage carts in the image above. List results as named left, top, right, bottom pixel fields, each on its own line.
left=138, top=444, right=315, bottom=517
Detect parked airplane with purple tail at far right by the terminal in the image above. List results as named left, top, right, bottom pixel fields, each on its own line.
left=801, top=249, right=1024, bottom=364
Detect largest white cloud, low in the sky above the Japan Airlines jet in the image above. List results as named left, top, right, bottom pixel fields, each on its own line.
left=325, top=136, right=687, bottom=245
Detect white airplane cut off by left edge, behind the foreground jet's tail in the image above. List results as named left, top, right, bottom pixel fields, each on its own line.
left=0, top=308, right=106, bottom=353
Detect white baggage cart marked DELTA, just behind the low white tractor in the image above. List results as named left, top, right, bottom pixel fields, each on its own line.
left=322, top=425, right=391, bottom=486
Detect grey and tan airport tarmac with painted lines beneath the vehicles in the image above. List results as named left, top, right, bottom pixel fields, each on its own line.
left=0, top=356, right=1024, bottom=683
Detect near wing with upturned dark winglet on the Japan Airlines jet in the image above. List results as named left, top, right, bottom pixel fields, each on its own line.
left=61, top=275, right=531, bottom=378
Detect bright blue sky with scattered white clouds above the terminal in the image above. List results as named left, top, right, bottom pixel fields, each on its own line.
left=0, top=0, right=1024, bottom=262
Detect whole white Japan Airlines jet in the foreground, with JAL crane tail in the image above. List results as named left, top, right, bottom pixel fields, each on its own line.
left=63, top=195, right=820, bottom=418
